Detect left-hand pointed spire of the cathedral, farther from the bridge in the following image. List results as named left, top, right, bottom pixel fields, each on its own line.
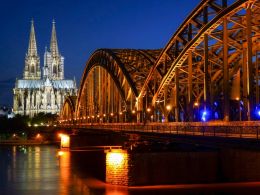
left=23, top=20, right=41, bottom=80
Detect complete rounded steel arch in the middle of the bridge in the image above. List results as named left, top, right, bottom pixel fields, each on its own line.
left=76, top=49, right=160, bottom=122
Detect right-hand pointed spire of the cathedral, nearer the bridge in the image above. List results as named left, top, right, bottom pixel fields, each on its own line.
left=43, top=20, right=64, bottom=80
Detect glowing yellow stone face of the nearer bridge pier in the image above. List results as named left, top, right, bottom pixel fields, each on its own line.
left=106, top=149, right=129, bottom=185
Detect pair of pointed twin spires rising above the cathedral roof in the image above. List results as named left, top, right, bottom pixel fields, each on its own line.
left=24, top=20, right=64, bottom=79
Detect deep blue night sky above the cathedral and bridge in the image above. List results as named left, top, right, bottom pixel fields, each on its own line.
left=0, top=0, right=200, bottom=106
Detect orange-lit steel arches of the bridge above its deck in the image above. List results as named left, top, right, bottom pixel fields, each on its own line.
left=61, top=0, right=260, bottom=125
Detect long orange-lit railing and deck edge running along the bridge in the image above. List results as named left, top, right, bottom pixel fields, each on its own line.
left=60, top=121, right=260, bottom=139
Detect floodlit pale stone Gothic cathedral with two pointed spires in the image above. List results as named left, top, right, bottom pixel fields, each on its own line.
left=13, top=21, right=77, bottom=117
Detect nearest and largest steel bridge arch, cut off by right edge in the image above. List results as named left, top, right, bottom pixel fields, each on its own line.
left=138, top=0, right=260, bottom=121
